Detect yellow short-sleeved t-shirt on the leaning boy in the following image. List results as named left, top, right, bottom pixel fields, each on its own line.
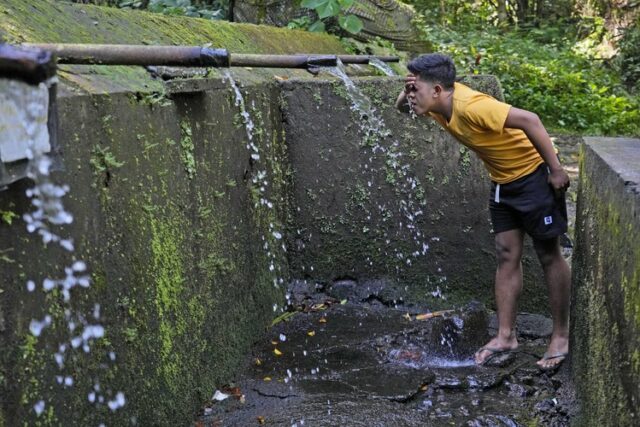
left=429, top=83, right=544, bottom=184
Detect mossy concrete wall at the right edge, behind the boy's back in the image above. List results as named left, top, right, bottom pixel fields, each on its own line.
left=571, top=138, right=640, bottom=427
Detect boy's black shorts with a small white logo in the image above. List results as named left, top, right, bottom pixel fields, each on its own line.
left=489, top=163, right=567, bottom=240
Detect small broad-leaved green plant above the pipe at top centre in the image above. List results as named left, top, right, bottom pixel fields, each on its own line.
left=289, top=0, right=363, bottom=34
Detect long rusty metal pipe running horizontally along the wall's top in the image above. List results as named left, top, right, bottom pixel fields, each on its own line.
left=23, top=43, right=399, bottom=68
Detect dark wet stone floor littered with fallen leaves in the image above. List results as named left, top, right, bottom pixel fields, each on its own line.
left=198, top=281, right=576, bottom=426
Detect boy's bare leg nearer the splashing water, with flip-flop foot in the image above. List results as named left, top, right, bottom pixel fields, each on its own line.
left=475, top=229, right=524, bottom=364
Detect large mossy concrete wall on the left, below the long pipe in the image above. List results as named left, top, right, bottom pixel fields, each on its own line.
left=0, top=80, right=288, bottom=425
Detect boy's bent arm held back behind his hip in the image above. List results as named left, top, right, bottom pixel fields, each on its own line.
left=504, top=107, right=569, bottom=191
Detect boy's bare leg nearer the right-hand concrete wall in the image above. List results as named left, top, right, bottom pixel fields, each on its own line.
left=533, top=237, right=571, bottom=368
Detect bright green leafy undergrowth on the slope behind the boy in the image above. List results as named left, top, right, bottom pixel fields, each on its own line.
left=425, top=26, right=640, bottom=135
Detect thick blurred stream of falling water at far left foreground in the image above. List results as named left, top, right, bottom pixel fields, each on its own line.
left=0, top=79, right=125, bottom=416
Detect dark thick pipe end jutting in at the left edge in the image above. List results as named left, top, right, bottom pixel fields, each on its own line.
left=0, top=44, right=56, bottom=85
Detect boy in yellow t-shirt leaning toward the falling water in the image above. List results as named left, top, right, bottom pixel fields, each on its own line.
left=396, top=54, right=571, bottom=370
